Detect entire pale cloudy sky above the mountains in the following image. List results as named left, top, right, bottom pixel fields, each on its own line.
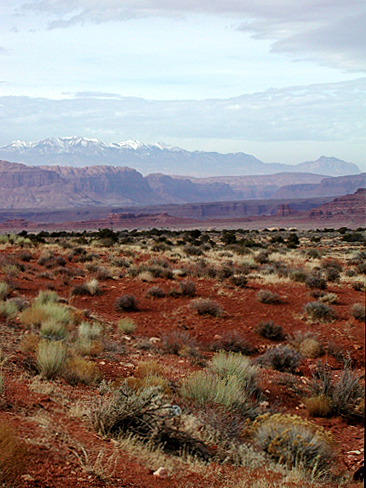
left=0, top=0, right=366, bottom=170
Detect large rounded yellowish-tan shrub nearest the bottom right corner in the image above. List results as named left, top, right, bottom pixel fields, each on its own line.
left=251, top=414, right=333, bottom=477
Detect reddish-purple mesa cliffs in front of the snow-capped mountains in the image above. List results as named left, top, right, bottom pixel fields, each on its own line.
left=0, top=161, right=366, bottom=209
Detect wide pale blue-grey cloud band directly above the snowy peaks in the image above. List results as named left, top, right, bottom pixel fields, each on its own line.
left=0, top=78, right=366, bottom=144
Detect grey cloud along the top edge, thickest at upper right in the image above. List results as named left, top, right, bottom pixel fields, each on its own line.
left=18, top=0, right=366, bottom=71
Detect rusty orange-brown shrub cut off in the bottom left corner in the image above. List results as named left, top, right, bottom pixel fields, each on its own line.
left=0, top=422, right=27, bottom=486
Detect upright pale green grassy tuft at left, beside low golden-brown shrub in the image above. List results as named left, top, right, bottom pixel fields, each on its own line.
left=36, top=339, right=67, bottom=379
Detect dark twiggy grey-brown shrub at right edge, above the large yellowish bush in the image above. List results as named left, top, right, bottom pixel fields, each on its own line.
left=310, top=359, right=365, bottom=417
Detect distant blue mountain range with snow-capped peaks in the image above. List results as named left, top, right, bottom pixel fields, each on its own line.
left=0, top=137, right=361, bottom=177
